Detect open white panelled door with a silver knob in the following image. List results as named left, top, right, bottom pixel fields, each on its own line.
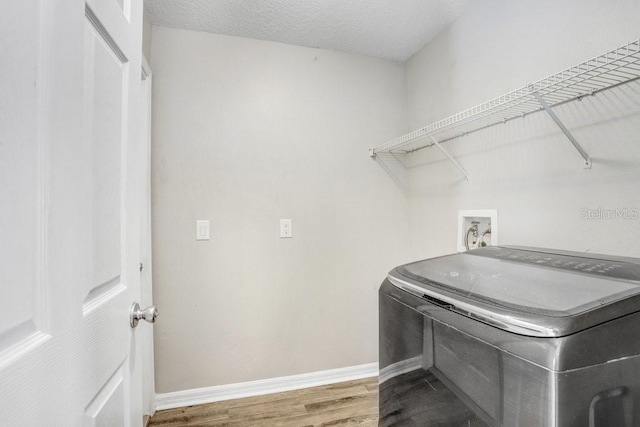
left=0, top=0, right=149, bottom=427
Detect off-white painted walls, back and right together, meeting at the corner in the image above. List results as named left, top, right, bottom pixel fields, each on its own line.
left=151, top=0, right=640, bottom=393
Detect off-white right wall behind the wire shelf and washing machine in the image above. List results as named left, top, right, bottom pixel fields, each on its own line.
left=407, top=0, right=640, bottom=259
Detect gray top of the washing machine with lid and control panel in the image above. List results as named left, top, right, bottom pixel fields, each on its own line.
left=389, top=247, right=640, bottom=337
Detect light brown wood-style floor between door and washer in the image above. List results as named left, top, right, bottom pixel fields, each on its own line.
left=149, top=377, right=378, bottom=427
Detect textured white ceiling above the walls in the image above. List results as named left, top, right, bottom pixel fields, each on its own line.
left=145, top=0, right=471, bottom=61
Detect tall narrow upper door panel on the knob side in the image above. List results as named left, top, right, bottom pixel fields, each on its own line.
left=84, top=7, right=129, bottom=301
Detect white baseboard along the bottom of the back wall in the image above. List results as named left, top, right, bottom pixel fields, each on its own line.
left=156, top=363, right=378, bottom=410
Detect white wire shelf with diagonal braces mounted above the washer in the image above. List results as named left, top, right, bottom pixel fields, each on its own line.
left=369, top=39, right=640, bottom=163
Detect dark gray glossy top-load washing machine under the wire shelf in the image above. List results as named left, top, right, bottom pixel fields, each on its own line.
left=379, top=247, right=640, bottom=427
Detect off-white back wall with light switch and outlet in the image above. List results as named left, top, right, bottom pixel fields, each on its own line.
left=151, top=27, right=407, bottom=393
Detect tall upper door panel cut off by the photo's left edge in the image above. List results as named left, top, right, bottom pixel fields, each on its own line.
left=0, top=0, right=44, bottom=360
